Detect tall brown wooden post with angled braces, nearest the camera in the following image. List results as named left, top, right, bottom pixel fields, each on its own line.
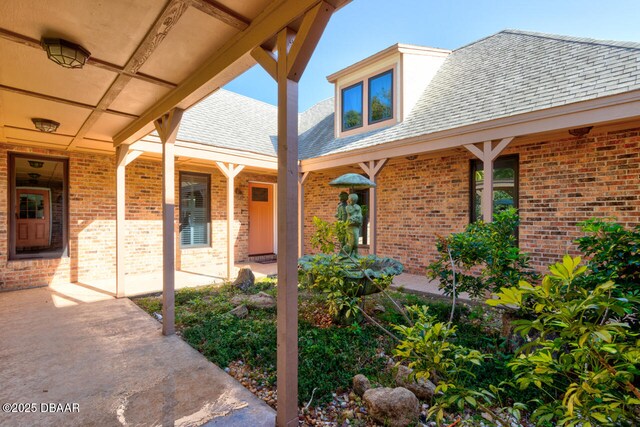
left=251, top=1, right=335, bottom=427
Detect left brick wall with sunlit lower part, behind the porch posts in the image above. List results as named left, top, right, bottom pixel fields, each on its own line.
left=0, top=144, right=276, bottom=290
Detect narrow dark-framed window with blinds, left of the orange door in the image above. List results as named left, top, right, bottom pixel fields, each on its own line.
left=179, top=172, right=211, bottom=248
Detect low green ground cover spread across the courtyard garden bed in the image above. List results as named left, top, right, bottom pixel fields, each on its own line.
left=135, top=280, right=524, bottom=404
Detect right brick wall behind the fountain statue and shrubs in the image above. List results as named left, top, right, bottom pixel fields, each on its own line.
left=305, top=125, right=640, bottom=274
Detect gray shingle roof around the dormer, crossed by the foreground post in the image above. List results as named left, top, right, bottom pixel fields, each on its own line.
left=178, top=30, right=640, bottom=159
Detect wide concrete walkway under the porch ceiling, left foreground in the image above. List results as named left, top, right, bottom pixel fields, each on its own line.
left=0, top=285, right=275, bottom=426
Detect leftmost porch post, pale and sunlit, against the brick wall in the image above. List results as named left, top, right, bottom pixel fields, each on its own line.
left=116, top=145, right=129, bottom=298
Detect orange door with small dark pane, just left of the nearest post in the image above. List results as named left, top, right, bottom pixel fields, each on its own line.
left=249, top=183, right=273, bottom=255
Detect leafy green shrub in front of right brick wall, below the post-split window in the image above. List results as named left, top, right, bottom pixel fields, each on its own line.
left=427, top=208, right=536, bottom=298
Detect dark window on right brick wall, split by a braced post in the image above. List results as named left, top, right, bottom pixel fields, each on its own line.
left=470, top=156, right=518, bottom=222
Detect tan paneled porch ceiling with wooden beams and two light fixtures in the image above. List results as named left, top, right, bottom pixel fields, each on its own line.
left=0, top=0, right=345, bottom=156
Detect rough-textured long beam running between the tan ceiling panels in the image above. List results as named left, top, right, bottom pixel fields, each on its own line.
left=67, top=0, right=190, bottom=149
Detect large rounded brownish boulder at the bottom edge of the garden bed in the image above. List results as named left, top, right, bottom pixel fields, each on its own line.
left=363, top=387, right=420, bottom=427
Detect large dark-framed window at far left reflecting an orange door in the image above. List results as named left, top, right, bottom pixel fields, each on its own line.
left=9, top=153, right=69, bottom=259
